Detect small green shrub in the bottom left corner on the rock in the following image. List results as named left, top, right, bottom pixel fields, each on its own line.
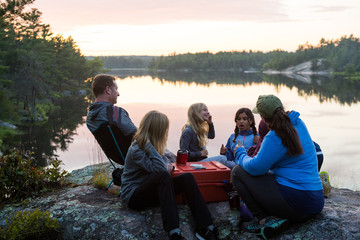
left=0, top=209, right=62, bottom=240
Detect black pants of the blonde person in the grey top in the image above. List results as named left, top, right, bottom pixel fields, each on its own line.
left=128, top=172, right=213, bottom=232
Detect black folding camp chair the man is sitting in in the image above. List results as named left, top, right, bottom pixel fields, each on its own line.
left=92, top=122, right=132, bottom=190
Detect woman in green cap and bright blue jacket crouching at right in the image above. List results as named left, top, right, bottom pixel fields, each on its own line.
left=231, top=95, right=324, bottom=239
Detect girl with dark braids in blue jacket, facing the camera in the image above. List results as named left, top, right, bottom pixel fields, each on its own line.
left=220, top=108, right=259, bottom=168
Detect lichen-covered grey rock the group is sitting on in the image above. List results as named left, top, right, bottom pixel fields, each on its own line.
left=0, top=167, right=360, bottom=240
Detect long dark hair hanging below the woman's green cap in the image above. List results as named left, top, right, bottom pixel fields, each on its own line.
left=264, top=107, right=304, bottom=156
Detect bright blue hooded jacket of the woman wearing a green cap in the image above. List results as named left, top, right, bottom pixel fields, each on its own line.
left=235, top=111, right=322, bottom=191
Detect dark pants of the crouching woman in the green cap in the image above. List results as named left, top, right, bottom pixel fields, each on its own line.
left=231, top=165, right=311, bottom=222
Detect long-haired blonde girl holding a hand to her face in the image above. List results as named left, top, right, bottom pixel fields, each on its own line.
left=180, top=103, right=227, bottom=163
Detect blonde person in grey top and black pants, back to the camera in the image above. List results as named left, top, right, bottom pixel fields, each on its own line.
left=121, top=111, right=218, bottom=239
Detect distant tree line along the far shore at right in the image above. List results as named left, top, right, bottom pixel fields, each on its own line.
left=149, top=35, right=360, bottom=74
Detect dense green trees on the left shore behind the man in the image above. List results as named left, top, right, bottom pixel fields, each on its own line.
left=0, top=0, right=103, bottom=125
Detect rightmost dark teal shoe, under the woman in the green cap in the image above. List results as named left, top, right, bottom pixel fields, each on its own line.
left=256, top=217, right=290, bottom=239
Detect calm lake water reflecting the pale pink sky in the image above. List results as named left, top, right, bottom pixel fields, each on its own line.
left=52, top=73, right=360, bottom=190
